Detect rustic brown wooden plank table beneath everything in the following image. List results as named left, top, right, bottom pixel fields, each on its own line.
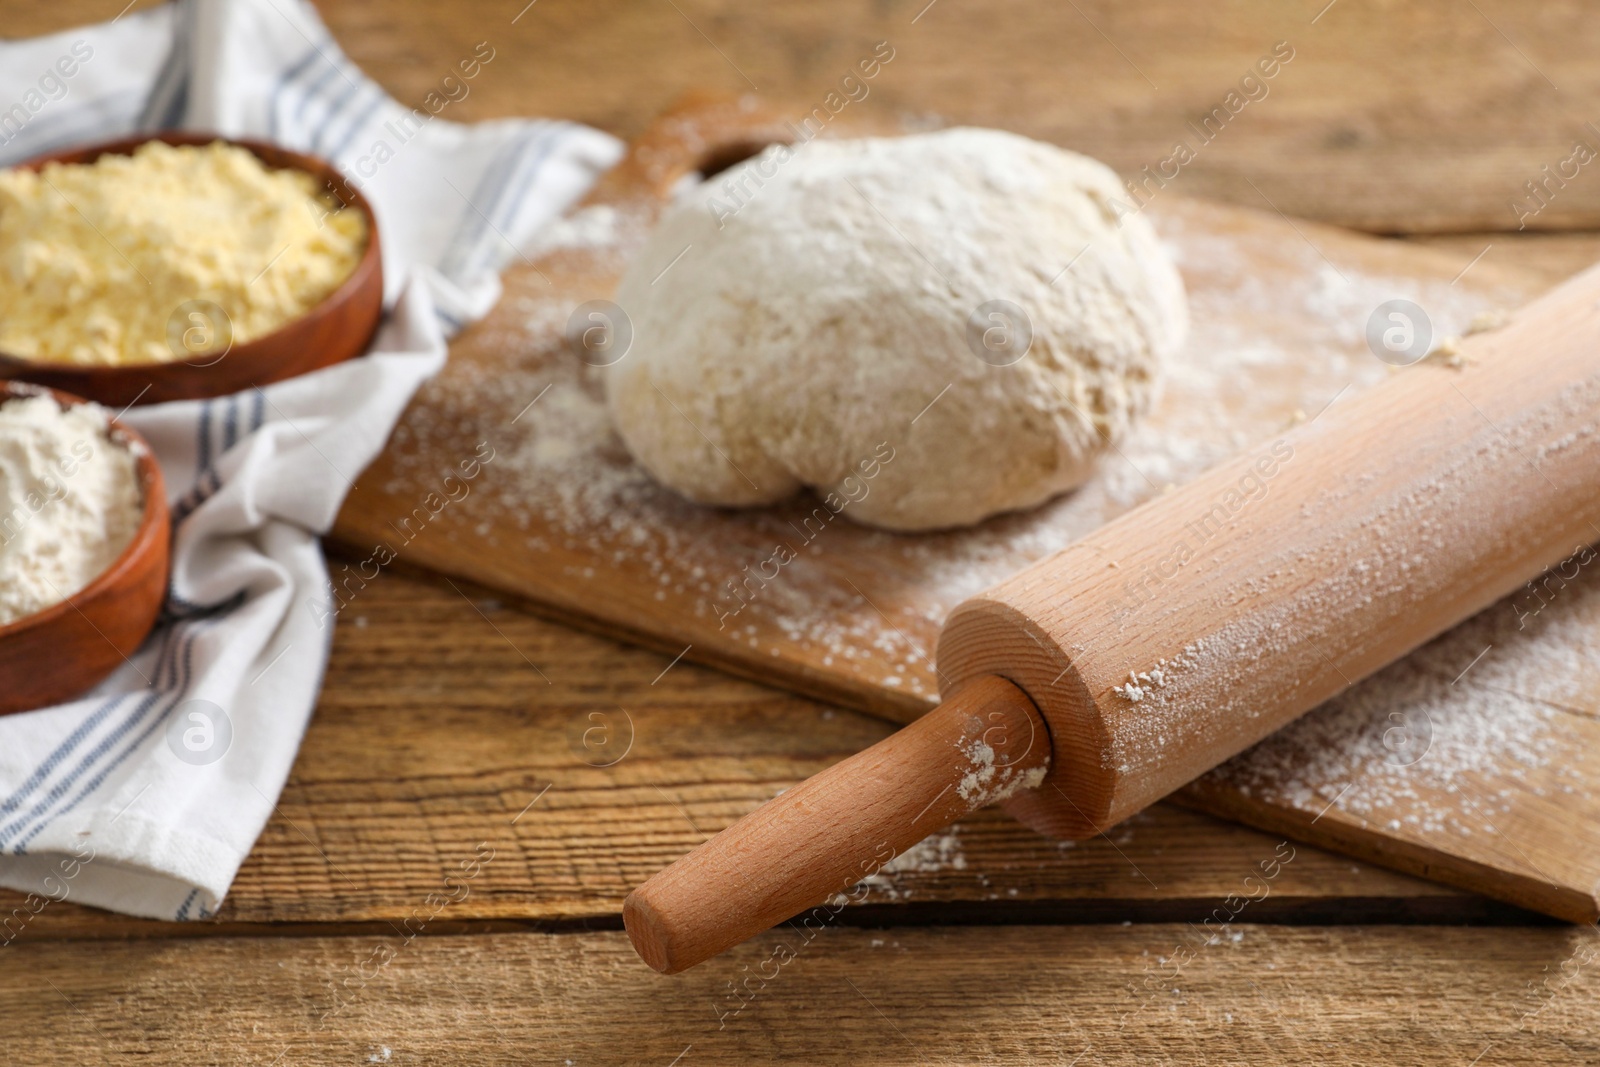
left=9, top=0, right=1600, bottom=1067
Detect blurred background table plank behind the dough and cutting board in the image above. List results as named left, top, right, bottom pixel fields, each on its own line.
left=15, top=0, right=1600, bottom=234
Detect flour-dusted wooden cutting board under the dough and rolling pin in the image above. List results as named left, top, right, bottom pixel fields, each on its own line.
left=333, top=101, right=1600, bottom=921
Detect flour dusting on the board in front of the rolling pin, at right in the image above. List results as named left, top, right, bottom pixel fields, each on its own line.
left=1206, top=565, right=1600, bottom=838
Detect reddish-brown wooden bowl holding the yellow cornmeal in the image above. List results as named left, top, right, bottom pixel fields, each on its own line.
left=0, top=131, right=384, bottom=408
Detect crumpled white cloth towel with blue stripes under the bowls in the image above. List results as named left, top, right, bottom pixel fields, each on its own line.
left=0, top=0, right=621, bottom=921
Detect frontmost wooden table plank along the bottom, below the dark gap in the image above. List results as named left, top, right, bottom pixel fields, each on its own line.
left=12, top=923, right=1600, bottom=1067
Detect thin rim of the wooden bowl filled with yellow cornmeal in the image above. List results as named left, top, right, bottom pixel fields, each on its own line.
left=0, top=130, right=382, bottom=379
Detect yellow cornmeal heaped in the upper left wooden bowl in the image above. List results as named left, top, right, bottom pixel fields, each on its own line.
left=0, top=141, right=368, bottom=366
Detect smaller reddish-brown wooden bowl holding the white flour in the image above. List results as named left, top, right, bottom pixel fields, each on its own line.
left=0, top=382, right=170, bottom=715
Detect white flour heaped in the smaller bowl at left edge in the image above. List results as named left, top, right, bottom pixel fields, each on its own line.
left=0, top=395, right=144, bottom=625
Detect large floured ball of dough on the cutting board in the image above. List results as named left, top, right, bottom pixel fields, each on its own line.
left=606, top=130, right=1187, bottom=530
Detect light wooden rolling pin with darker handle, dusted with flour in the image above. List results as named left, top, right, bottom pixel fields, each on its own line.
left=622, top=267, right=1600, bottom=974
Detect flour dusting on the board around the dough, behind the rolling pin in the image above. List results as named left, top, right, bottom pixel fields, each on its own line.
left=382, top=203, right=1522, bottom=707
